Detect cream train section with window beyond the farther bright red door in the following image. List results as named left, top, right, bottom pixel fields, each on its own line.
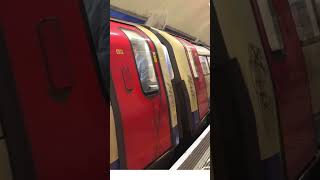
left=195, top=46, right=210, bottom=104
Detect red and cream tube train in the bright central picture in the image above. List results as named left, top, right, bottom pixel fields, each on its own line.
left=110, top=19, right=210, bottom=169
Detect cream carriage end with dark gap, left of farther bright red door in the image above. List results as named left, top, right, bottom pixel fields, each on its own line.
left=149, top=28, right=200, bottom=136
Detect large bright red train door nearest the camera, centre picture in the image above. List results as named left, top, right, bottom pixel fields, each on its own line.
left=110, top=21, right=171, bottom=169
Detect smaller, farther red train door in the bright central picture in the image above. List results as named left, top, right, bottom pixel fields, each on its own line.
left=178, top=38, right=209, bottom=120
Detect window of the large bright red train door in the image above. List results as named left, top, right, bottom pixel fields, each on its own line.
left=121, top=28, right=159, bottom=95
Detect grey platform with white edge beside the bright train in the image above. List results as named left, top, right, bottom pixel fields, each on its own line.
left=170, top=125, right=210, bottom=170
